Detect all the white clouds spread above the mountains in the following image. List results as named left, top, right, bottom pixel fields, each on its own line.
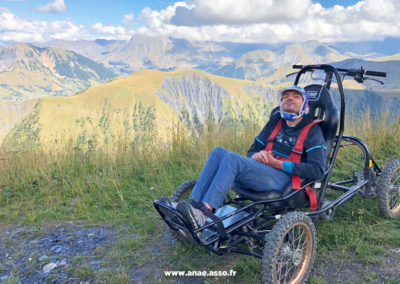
left=0, top=0, right=400, bottom=43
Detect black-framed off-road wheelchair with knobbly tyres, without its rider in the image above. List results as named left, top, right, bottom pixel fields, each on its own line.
left=154, top=65, right=400, bottom=283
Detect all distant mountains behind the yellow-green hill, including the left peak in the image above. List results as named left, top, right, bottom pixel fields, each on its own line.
left=0, top=36, right=400, bottom=100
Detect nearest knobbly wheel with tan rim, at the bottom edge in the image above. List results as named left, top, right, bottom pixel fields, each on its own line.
left=262, top=212, right=317, bottom=284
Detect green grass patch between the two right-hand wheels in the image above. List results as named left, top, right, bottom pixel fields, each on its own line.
left=317, top=197, right=400, bottom=264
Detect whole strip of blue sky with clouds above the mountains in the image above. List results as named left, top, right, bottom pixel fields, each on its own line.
left=0, top=0, right=400, bottom=43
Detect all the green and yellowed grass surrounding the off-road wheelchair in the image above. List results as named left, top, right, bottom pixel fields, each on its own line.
left=0, top=111, right=400, bottom=283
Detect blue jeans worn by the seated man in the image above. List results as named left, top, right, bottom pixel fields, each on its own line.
left=191, top=147, right=291, bottom=209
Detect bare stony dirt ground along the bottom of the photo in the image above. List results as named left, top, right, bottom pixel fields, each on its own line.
left=0, top=222, right=400, bottom=283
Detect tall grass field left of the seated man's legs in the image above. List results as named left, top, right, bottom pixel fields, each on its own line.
left=0, top=120, right=255, bottom=226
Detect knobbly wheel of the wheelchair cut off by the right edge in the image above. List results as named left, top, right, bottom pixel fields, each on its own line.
left=378, top=160, right=400, bottom=219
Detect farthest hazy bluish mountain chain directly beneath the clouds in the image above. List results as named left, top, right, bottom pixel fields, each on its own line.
left=41, top=35, right=400, bottom=79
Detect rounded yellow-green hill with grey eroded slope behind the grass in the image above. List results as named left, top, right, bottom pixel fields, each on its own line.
left=3, top=71, right=277, bottom=150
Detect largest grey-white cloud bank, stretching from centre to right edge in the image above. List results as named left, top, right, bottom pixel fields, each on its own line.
left=138, top=0, right=400, bottom=43
